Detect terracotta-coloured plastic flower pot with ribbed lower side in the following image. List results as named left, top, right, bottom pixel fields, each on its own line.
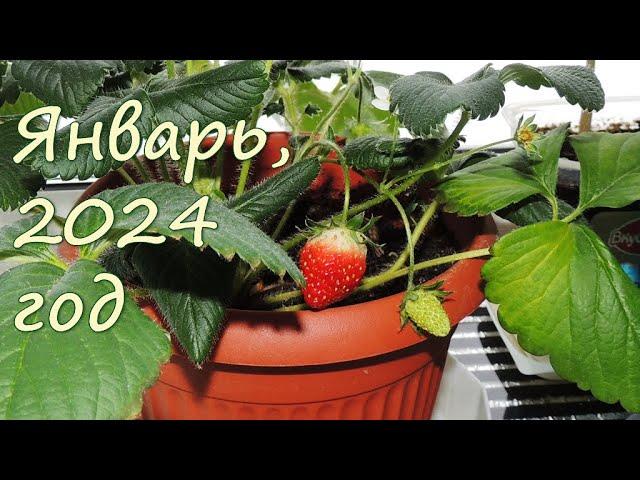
left=75, top=132, right=495, bottom=419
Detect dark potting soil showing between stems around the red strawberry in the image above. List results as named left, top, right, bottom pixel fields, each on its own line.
left=253, top=189, right=457, bottom=308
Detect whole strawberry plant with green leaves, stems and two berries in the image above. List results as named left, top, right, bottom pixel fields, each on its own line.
left=0, top=60, right=640, bottom=418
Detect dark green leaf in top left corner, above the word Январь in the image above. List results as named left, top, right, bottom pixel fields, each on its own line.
left=11, top=60, right=121, bottom=117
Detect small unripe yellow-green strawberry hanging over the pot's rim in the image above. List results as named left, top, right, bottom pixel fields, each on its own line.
left=401, top=288, right=451, bottom=337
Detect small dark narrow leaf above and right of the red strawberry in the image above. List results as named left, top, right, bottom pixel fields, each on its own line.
left=343, top=136, right=440, bottom=171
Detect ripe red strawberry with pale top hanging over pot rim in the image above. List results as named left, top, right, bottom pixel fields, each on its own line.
left=299, top=227, right=367, bottom=309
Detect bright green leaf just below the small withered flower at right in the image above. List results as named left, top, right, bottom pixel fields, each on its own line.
left=437, top=125, right=567, bottom=216
